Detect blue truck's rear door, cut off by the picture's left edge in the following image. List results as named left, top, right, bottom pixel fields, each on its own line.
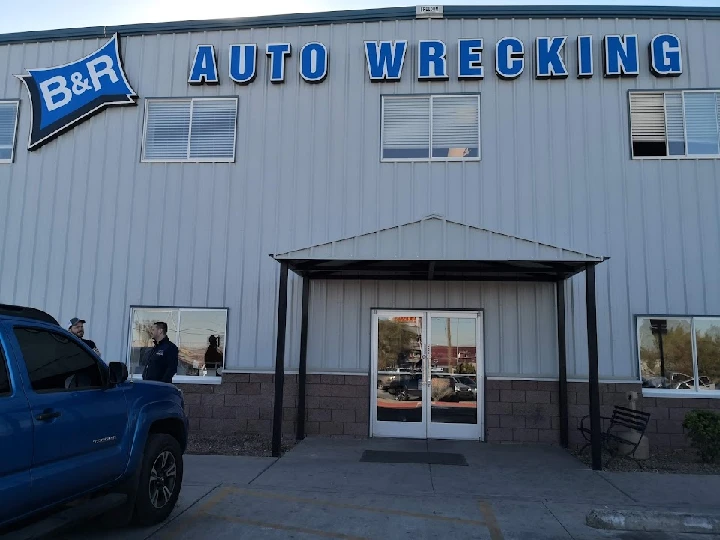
left=0, top=329, right=33, bottom=522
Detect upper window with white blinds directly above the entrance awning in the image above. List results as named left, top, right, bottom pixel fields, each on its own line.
left=381, top=94, right=480, bottom=161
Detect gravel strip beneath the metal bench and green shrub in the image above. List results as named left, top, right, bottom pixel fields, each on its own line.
left=570, top=448, right=720, bottom=474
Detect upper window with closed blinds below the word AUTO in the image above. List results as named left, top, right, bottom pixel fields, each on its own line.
left=143, top=98, right=238, bottom=163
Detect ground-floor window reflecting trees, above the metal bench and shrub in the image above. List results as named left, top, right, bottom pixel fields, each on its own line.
left=638, top=317, right=720, bottom=393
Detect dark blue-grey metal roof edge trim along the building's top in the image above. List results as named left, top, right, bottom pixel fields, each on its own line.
left=0, top=5, right=720, bottom=45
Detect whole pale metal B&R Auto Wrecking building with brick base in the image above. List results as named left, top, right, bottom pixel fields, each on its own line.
left=0, top=6, right=720, bottom=464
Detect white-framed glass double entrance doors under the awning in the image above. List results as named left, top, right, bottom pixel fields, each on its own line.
left=371, top=311, right=484, bottom=440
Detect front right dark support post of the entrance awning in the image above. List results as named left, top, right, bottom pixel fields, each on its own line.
left=585, top=264, right=602, bottom=471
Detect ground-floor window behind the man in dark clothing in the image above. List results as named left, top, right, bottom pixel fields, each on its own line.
left=128, top=307, right=227, bottom=379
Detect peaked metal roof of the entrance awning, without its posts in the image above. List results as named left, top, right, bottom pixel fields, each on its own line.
left=272, top=215, right=605, bottom=281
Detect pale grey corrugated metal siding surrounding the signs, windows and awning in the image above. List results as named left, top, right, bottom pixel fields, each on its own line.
left=0, top=19, right=720, bottom=378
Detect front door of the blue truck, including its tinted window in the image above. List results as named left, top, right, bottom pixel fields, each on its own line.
left=9, top=325, right=128, bottom=504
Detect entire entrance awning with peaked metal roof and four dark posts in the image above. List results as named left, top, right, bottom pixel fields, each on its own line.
left=271, top=215, right=608, bottom=469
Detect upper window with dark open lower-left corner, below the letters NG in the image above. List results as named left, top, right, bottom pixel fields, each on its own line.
left=630, top=90, right=720, bottom=158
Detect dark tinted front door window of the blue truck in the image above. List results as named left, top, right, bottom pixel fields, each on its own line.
left=15, top=328, right=102, bottom=392
